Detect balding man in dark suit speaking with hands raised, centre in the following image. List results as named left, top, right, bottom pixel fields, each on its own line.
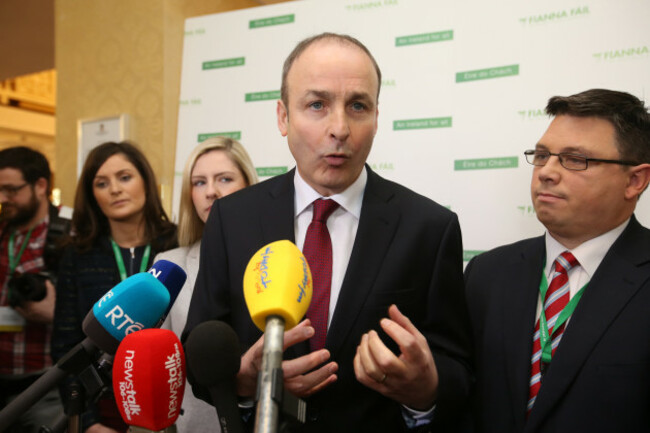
left=185, top=34, right=470, bottom=432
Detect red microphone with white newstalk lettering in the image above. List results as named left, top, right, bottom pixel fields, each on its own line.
left=113, top=328, right=186, bottom=433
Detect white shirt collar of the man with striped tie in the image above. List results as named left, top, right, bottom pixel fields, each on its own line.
left=544, top=218, right=630, bottom=279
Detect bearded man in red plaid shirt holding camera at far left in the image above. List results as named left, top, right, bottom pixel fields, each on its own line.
left=0, top=147, right=68, bottom=432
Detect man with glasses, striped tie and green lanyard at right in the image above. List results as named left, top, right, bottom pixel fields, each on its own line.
left=465, top=89, right=650, bottom=433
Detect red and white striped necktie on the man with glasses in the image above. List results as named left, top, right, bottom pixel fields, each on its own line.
left=526, top=251, right=578, bottom=414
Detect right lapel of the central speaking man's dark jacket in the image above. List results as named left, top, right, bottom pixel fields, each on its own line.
left=326, top=168, right=400, bottom=357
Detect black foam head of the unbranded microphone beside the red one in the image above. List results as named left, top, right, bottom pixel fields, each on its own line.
left=185, top=320, right=241, bottom=388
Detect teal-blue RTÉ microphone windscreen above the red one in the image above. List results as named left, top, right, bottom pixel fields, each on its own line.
left=82, top=272, right=169, bottom=354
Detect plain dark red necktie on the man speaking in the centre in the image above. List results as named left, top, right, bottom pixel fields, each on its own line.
left=302, top=199, right=339, bottom=352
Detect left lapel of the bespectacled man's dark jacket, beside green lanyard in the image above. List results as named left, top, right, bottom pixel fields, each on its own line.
left=500, top=236, right=545, bottom=431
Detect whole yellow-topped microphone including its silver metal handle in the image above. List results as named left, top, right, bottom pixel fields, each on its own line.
left=244, top=240, right=312, bottom=432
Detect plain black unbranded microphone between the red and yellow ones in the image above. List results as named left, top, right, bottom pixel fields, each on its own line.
left=185, top=320, right=244, bottom=433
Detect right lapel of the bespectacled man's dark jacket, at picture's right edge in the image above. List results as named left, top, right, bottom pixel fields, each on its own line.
left=526, top=217, right=650, bottom=431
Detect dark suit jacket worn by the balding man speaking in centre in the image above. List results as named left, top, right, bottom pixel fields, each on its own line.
left=184, top=169, right=471, bottom=432
